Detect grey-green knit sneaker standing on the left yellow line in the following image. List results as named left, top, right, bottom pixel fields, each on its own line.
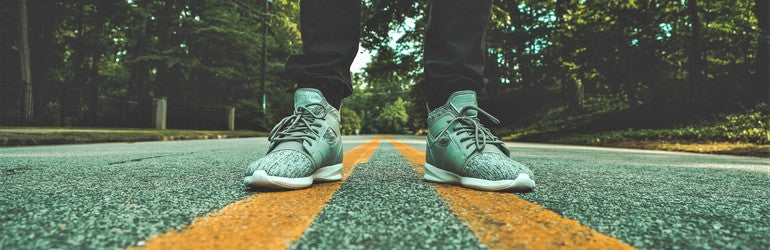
left=243, top=88, right=342, bottom=189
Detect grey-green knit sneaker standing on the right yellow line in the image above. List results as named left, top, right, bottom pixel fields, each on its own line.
left=425, top=90, right=535, bottom=191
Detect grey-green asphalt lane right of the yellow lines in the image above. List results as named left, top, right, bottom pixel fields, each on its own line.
left=396, top=136, right=770, bottom=249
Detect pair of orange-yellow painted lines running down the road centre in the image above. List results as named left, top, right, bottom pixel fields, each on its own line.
left=135, top=136, right=632, bottom=249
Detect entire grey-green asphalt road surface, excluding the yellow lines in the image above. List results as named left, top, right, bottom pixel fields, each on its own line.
left=0, top=136, right=770, bottom=249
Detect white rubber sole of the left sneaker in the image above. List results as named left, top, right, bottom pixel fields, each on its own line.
left=243, top=163, right=342, bottom=189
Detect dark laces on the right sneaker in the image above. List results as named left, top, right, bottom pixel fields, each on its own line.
left=434, top=106, right=505, bottom=151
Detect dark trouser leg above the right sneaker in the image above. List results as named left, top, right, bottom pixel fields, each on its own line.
left=424, top=0, right=492, bottom=108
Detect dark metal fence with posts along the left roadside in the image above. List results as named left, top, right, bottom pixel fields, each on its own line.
left=0, top=81, right=262, bottom=130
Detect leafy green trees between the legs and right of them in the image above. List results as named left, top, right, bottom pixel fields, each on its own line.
left=363, top=0, right=768, bottom=136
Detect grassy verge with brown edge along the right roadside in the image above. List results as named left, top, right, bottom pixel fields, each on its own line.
left=503, top=104, right=770, bottom=156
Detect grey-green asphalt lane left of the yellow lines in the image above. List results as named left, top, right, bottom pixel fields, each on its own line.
left=0, top=137, right=371, bottom=249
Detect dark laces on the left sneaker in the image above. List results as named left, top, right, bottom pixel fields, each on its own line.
left=267, top=103, right=326, bottom=146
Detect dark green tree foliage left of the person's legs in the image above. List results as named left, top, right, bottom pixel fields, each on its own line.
left=0, top=0, right=301, bottom=129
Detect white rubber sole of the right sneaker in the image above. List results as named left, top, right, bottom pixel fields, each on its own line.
left=425, top=163, right=535, bottom=192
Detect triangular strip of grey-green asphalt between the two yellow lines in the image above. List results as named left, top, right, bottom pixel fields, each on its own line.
left=291, top=141, right=485, bottom=249
